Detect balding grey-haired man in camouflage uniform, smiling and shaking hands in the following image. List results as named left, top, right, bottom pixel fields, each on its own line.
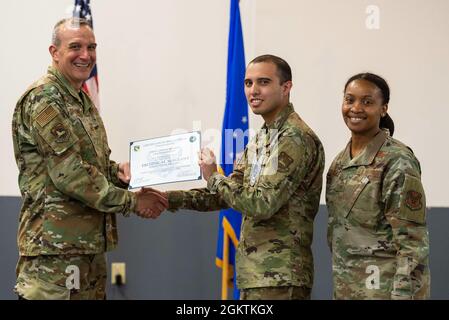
left=12, top=19, right=168, bottom=299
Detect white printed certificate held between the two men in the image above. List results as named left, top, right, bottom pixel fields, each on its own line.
left=129, top=131, right=201, bottom=189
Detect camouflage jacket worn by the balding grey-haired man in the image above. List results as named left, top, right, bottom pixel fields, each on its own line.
left=12, top=67, right=136, bottom=256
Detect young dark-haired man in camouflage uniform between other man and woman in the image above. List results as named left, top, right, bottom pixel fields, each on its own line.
left=164, top=55, right=324, bottom=299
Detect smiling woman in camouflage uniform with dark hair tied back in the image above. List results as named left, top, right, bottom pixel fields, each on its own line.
left=326, top=73, right=430, bottom=299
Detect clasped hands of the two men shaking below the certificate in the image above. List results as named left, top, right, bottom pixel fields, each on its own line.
left=136, top=188, right=168, bottom=219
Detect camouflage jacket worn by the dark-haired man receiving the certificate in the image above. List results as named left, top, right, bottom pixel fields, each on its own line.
left=168, top=104, right=324, bottom=289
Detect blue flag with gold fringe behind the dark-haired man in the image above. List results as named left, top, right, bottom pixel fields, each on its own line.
left=216, top=0, right=248, bottom=299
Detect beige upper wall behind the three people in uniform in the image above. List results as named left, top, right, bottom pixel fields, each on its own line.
left=0, top=0, right=449, bottom=206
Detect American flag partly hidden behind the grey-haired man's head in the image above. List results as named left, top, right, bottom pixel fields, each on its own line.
left=73, top=0, right=100, bottom=109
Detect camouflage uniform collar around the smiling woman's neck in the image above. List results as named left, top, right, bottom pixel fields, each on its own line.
left=342, top=130, right=389, bottom=169
